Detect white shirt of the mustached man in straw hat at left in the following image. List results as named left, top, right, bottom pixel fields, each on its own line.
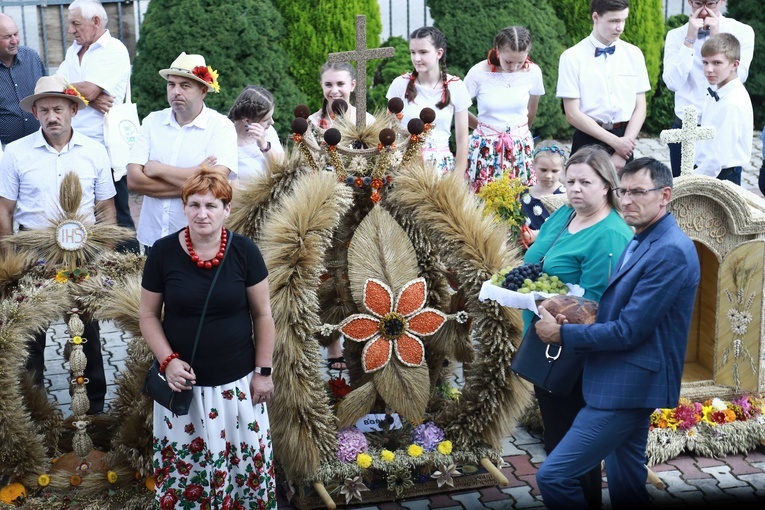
left=0, top=129, right=116, bottom=229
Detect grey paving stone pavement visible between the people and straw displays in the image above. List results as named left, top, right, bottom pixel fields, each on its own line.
left=45, top=132, right=765, bottom=510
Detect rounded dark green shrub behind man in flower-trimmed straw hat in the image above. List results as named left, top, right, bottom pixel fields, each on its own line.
left=132, top=0, right=305, bottom=137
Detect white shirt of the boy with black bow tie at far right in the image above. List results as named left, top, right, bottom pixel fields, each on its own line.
left=694, top=78, right=754, bottom=177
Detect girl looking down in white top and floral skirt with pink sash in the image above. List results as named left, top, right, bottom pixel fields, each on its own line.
left=465, top=26, right=545, bottom=192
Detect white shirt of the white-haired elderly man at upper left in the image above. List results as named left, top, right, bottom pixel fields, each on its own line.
left=56, top=30, right=130, bottom=147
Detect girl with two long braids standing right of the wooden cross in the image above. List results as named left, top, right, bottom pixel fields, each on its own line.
left=387, top=27, right=473, bottom=175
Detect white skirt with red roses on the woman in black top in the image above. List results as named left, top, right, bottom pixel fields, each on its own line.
left=154, top=374, right=276, bottom=510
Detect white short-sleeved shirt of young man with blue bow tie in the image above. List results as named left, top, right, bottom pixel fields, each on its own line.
left=556, top=34, right=651, bottom=124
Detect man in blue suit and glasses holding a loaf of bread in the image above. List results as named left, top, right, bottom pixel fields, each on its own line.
left=536, top=158, right=700, bottom=509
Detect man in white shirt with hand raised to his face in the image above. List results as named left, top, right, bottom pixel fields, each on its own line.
left=662, top=0, right=754, bottom=177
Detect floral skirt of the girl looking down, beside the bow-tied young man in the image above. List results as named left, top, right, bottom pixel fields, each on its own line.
left=465, top=127, right=534, bottom=192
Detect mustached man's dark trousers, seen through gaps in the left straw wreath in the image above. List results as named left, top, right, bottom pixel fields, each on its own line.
left=27, top=321, right=106, bottom=414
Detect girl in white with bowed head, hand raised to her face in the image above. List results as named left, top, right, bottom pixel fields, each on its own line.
left=228, top=85, right=284, bottom=187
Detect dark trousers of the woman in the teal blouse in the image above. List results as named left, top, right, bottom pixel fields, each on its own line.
left=534, top=376, right=603, bottom=509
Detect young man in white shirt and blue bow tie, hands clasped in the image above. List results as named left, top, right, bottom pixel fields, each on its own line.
left=556, top=0, right=651, bottom=168
